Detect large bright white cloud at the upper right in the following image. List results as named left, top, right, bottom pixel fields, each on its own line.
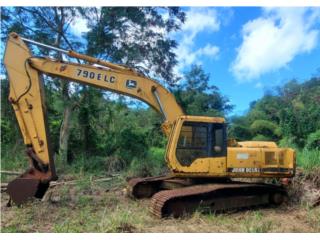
left=231, top=8, right=320, bottom=82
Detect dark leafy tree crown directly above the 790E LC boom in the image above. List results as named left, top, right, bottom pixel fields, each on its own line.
left=87, top=7, right=185, bottom=84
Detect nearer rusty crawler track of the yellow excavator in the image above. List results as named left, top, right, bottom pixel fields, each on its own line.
left=150, top=183, right=284, bottom=218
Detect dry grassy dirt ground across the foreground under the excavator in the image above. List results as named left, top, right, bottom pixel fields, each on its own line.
left=1, top=174, right=320, bottom=233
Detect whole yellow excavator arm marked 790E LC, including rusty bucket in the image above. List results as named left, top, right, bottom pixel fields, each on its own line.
left=4, top=33, right=183, bottom=204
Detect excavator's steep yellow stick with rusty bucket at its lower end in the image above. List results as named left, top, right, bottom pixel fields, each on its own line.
left=4, top=33, right=57, bottom=204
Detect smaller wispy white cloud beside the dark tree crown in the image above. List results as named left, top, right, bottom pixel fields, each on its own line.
left=176, top=7, right=220, bottom=74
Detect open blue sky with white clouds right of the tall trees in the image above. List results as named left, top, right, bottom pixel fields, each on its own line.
left=162, top=7, right=320, bottom=114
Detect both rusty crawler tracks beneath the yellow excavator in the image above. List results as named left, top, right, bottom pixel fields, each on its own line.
left=128, top=176, right=287, bottom=218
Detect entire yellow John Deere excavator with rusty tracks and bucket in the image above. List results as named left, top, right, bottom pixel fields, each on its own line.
left=4, top=33, right=295, bottom=217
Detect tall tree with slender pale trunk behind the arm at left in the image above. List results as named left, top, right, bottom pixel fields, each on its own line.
left=1, top=7, right=86, bottom=164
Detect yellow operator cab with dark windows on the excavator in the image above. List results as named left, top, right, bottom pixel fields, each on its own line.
left=166, top=116, right=227, bottom=171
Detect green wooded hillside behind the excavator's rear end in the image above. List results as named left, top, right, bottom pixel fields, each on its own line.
left=230, top=77, right=320, bottom=148
